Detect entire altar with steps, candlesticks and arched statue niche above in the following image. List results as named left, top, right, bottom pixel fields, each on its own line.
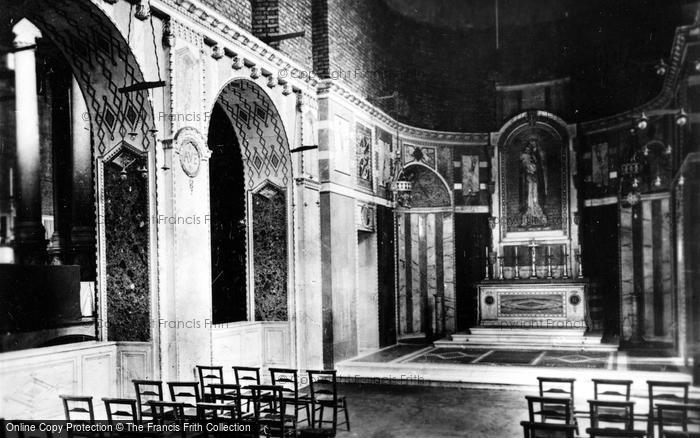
left=441, top=111, right=613, bottom=348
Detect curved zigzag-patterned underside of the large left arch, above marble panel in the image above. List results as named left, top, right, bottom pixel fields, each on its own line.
left=9, top=0, right=155, bottom=156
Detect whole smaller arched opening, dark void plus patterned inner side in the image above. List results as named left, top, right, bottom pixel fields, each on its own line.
left=209, top=80, right=291, bottom=324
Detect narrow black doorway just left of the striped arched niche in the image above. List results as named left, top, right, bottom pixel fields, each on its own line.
left=377, top=205, right=396, bottom=347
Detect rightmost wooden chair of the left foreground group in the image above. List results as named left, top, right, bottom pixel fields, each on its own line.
left=307, top=370, right=350, bottom=431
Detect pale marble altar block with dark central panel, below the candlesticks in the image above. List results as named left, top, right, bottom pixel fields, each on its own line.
left=479, top=283, right=586, bottom=328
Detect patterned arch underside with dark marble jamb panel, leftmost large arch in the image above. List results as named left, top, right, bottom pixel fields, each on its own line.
left=6, top=0, right=155, bottom=341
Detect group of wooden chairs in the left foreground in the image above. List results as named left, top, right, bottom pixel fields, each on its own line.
left=62, top=366, right=350, bottom=435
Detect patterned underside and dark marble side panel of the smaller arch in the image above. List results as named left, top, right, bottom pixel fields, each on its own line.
left=205, top=79, right=293, bottom=321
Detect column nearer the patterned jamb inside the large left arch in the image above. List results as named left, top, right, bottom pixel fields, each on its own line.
left=71, top=78, right=96, bottom=281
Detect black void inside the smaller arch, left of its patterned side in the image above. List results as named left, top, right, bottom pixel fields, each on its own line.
left=209, top=104, right=247, bottom=324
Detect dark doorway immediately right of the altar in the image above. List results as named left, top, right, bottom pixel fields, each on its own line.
left=581, top=204, right=620, bottom=337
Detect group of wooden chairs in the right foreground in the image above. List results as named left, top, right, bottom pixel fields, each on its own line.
left=521, top=377, right=700, bottom=438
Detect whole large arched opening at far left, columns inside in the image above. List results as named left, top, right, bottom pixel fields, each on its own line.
left=0, top=1, right=154, bottom=351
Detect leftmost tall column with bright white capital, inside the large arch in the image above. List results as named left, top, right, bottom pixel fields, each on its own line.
left=12, top=19, right=46, bottom=264
